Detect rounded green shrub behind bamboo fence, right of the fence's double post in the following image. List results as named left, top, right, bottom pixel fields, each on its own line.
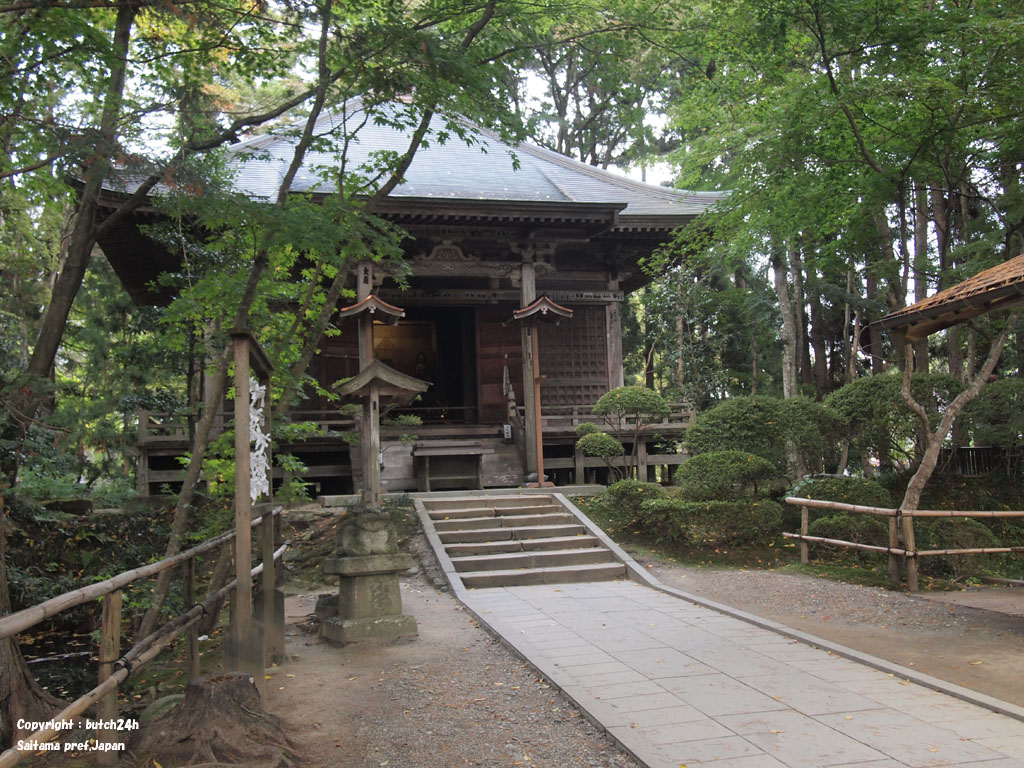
left=913, top=517, right=1004, bottom=579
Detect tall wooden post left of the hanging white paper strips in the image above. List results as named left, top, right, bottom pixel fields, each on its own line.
left=231, top=336, right=252, bottom=679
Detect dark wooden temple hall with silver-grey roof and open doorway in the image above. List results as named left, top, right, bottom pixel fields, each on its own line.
left=100, top=105, right=720, bottom=494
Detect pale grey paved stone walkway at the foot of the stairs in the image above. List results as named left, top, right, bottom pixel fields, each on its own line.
left=457, top=581, right=1024, bottom=768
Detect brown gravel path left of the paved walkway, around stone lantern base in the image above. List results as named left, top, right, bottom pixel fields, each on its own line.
left=265, top=575, right=637, bottom=768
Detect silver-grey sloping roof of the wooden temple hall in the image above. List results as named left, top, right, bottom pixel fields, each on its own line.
left=220, top=102, right=724, bottom=226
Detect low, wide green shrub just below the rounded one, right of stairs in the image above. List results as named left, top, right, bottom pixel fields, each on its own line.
left=663, top=499, right=782, bottom=544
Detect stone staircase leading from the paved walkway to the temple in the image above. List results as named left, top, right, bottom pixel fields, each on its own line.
left=422, top=495, right=626, bottom=588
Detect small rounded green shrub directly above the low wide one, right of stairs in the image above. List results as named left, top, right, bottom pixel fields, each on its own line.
left=676, top=451, right=778, bottom=501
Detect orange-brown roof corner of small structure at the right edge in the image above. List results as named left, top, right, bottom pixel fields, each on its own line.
left=878, top=254, right=1024, bottom=341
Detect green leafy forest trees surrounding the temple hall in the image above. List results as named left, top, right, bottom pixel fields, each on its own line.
left=0, top=0, right=1024, bottom=741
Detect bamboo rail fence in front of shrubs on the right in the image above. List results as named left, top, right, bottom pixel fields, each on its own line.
left=782, top=497, right=1024, bottom=592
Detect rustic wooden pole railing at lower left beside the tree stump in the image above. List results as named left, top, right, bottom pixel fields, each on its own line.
left=0, top=505, right=288, bottom=768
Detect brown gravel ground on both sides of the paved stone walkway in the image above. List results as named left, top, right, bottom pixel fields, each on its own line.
left=266, top=514, right=1024, bottom=768
